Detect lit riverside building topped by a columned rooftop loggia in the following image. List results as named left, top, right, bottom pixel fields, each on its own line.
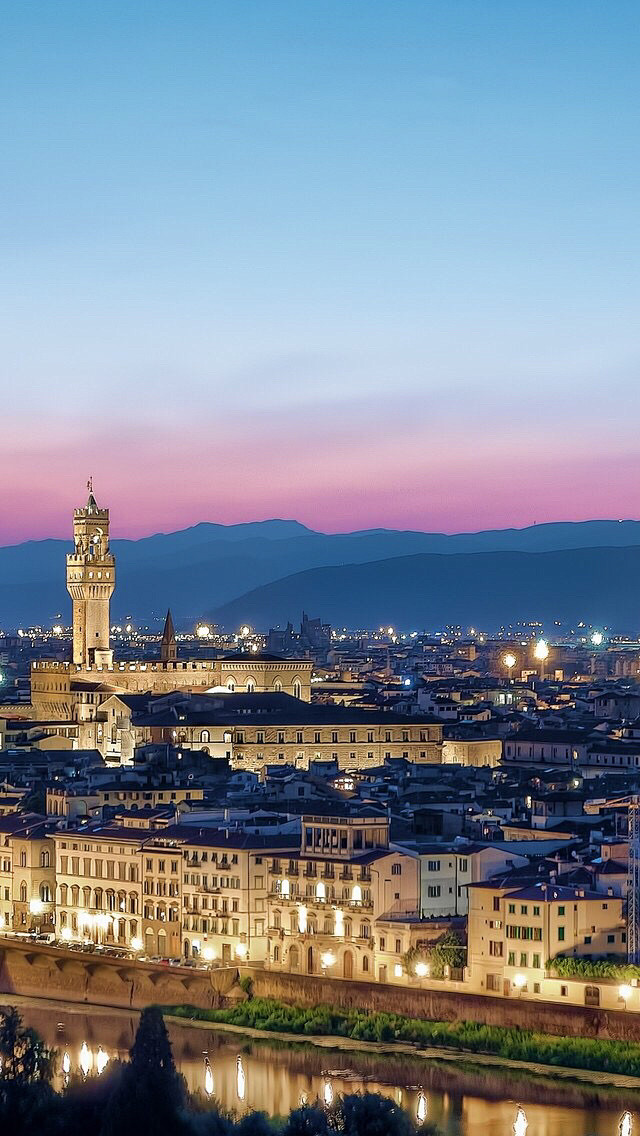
left=267, top=807, right=418, bottom=980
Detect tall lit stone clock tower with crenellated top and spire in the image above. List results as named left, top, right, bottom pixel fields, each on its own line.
left=67, top=481, right=116, bottom=667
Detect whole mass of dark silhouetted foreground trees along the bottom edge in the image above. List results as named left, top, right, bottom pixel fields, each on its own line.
left=0, top=1006, right=437, bottom=1136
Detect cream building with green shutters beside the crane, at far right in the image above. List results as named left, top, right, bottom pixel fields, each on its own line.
left=468, top=883, right=626, bottom=996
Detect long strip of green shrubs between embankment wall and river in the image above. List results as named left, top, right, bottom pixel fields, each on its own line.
left=163, top=999, right=640, bottom=1077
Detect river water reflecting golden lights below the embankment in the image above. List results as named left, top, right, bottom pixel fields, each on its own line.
left=6, top=999, right=640, bottom=1136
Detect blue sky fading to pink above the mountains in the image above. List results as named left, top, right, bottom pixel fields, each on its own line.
left=0, top=0, right=640, bottom=544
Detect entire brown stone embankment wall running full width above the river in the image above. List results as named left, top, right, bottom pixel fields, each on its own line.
left=0, top=939, right=640, bottom=1041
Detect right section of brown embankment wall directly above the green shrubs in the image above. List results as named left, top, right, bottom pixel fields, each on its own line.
left=241, top=967, right=640, bottom=1041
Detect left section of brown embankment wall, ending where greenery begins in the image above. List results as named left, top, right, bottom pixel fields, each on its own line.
left=0, top=941, right=237, bottom=1010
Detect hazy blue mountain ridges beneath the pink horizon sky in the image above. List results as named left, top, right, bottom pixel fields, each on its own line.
left=0, top=519, right=640, bottom=628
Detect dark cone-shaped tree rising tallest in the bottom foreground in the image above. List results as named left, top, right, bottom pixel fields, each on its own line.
left=102, top=1006, right=186, bottom=1136
